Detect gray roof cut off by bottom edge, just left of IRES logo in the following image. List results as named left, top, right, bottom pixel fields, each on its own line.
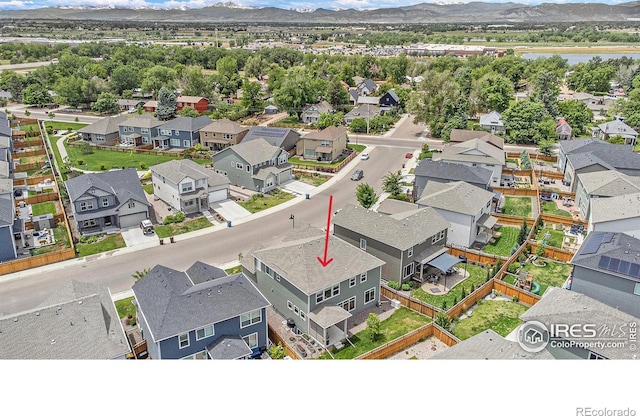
left=430, top=329, right=554, bottom=360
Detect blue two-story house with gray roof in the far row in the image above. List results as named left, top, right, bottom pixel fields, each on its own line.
left=153, top=116, right=213, bottom=149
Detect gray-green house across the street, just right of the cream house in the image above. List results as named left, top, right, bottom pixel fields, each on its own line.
left=212, top=138, right=293, bottom=192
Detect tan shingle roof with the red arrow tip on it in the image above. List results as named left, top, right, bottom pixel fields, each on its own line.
left=252, top=229, right=384, bottom=295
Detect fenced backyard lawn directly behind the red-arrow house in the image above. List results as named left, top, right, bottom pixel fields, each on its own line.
left=320, top=307, right=431, bottom=360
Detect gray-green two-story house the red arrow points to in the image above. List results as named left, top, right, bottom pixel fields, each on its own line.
left=241, top=227, right=384, bottom=347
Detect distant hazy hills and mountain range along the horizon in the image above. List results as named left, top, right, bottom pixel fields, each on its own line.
left=0, top=1, right=640, bottom=24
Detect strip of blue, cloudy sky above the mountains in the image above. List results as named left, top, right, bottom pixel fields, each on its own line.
left=0, top=0, right=625, bottom=10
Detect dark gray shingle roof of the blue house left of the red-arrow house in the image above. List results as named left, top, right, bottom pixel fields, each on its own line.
left=132, top=265, right=269, bottom=342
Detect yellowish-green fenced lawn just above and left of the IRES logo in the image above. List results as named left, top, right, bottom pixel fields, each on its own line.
left=451, top=300, right=528, bottom=340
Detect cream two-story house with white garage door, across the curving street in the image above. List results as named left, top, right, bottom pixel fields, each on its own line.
left=150, top=159, right=229, bottom=214
